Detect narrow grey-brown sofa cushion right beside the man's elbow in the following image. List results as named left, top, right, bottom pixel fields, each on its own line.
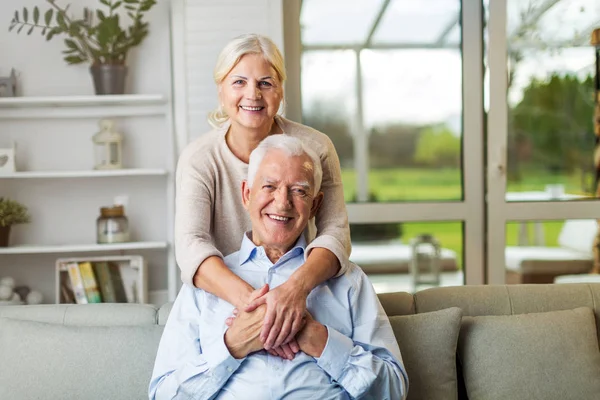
left=390, top=307, right=462, bottom=400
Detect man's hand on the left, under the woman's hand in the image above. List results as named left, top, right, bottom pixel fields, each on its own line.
left=225, top=306, right=267, bottom=359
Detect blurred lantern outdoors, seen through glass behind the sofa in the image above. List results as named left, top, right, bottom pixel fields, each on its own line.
left=410, top=234, right=442, bottom=290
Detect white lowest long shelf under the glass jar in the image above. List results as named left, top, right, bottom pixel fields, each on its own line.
left=0, top=242, right=168, bottom=254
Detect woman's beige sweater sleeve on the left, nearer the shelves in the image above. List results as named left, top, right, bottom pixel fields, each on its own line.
left=175, top=147, right=223, bottom=286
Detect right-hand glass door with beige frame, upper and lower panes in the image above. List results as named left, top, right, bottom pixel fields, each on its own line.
left=485, top=0, right=600, bottom=283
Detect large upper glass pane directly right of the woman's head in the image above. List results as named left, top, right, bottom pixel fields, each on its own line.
left=300, top=0, right=463, bottom=202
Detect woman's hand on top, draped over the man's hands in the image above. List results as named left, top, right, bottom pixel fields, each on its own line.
left=244, top=280, right=309, bottom=350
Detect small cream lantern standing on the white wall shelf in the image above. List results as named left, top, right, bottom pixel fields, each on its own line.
left=92, top=119, right=123, bottom=169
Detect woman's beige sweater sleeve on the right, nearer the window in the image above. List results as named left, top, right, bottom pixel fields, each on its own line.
left=306, top=133, right=352, bottom=276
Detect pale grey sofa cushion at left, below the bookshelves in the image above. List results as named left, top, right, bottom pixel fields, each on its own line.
left=0, top=318, right=163, bottom=400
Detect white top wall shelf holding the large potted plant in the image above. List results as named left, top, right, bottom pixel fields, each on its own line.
left=0, top=94, right=168, bottom=119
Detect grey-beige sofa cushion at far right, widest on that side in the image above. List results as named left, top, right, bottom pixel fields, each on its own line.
left=458, top=307, right=600, bottom=400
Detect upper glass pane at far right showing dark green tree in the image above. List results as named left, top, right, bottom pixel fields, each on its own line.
left=506, top=0, right=600, bottom=201
